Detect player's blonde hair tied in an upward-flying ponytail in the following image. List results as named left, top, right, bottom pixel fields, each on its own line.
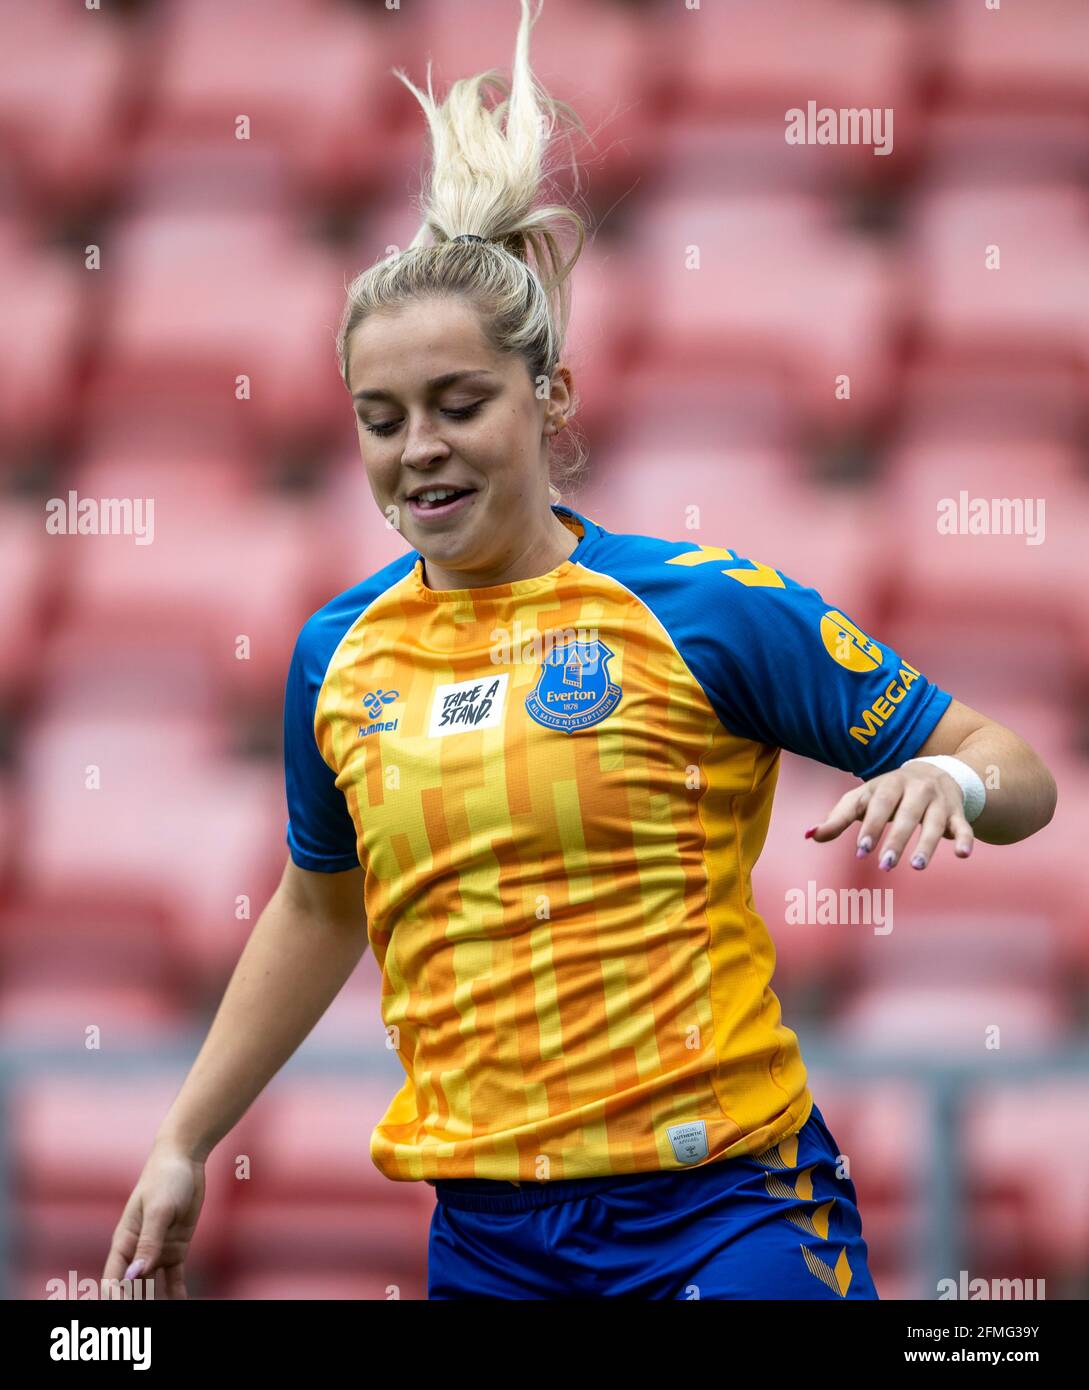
left=337, top=0, right=586, bottom=502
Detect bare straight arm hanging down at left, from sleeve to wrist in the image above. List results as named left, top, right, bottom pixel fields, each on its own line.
left=156, top=856, right=367, bottom=1159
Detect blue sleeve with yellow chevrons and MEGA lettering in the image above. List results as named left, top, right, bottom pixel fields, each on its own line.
left=675, top=556, right=953, bottom=780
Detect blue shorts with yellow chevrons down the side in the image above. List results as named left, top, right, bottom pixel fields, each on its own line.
left=427, top=1105, right=878, bottom=1300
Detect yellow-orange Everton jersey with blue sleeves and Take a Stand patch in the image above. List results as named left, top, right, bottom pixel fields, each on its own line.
left=284, top=506, right=951, bottom=1180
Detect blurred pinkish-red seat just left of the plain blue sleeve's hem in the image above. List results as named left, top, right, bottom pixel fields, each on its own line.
left=18, top=714, right=287, bottom=988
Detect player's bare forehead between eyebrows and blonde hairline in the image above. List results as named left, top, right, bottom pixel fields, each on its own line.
left=349, top=299, right=510, bottom=392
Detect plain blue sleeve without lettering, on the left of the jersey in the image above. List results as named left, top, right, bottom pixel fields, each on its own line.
left=284, top=619, right=359, bottom=873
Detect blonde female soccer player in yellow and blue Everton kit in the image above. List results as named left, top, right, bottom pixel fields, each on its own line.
left=106, top=0, right=1056, bottom=1300
